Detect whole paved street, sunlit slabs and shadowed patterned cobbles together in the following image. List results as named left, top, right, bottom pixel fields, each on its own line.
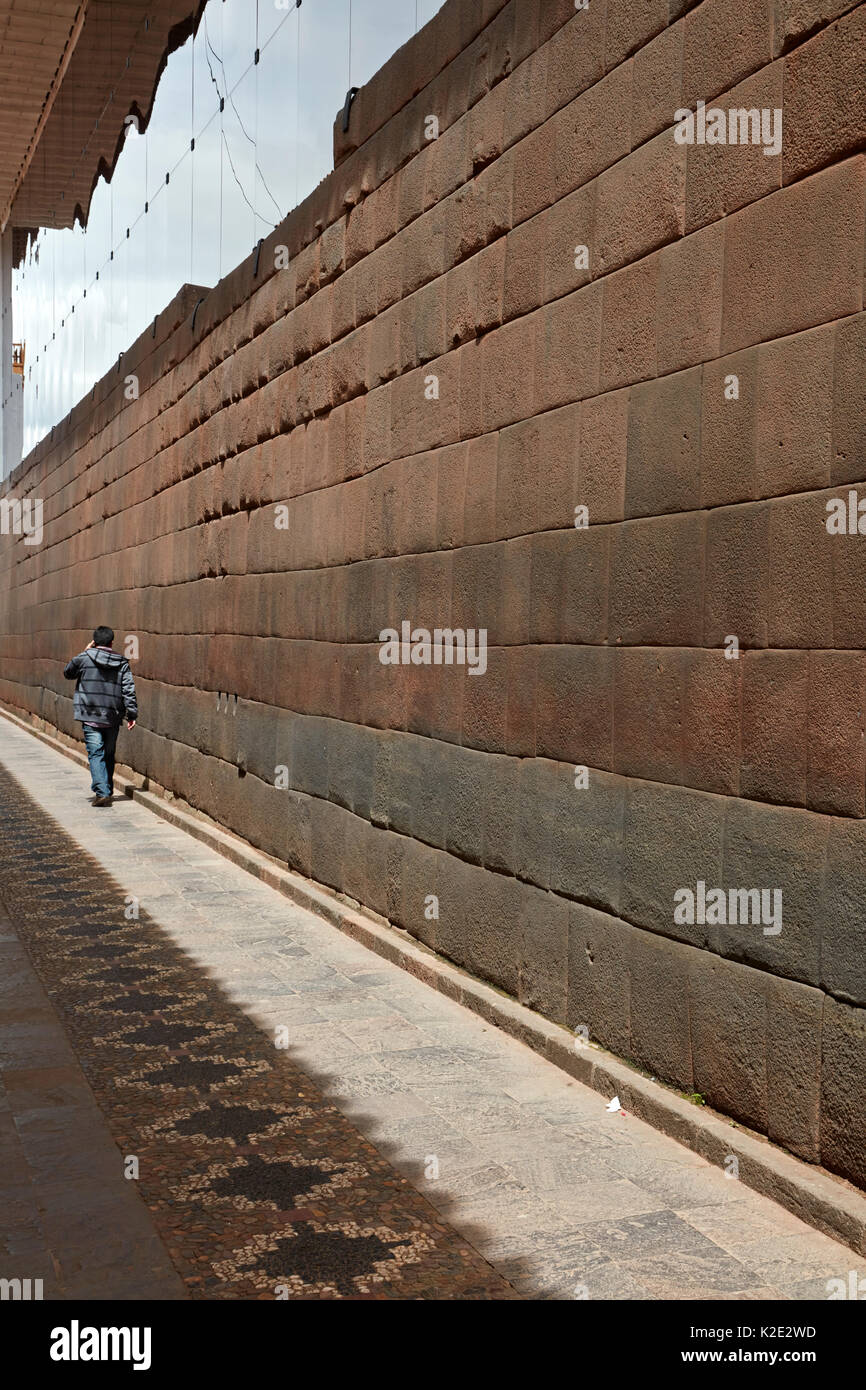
left=0, top=720, right=866, bottom=1300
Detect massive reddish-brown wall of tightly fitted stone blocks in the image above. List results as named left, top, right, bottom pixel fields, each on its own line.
left=0, top=0, right=866, bottom=1184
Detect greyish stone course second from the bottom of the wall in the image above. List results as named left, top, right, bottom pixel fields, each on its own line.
left=30, top=682, right=866, bottom=1006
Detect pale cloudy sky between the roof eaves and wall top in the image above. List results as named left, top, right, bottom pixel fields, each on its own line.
left=13, top=0, right=441, bottom=455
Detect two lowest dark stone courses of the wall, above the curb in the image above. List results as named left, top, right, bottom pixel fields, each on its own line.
left=1, top=700, right=866, bottom=1186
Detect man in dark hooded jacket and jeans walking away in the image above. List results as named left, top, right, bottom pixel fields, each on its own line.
left=63, top=627, right=139, bottom=806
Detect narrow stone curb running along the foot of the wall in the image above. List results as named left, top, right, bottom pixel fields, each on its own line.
left=0, top=703, right=866, bottom=1255
